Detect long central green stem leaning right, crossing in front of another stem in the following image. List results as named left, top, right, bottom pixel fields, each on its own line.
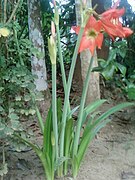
left=60, top=27, right=84, bottom=167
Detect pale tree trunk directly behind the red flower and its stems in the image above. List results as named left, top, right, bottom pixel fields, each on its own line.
left=75, top=0, right=100, bottom=105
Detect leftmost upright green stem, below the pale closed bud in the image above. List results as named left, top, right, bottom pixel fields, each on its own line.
left=52, top=64, right=58, bottom=160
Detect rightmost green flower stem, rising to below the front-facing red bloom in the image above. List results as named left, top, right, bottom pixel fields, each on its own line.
left=73, top=56, right=94, bottom=155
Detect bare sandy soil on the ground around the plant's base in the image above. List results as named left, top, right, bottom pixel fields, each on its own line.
left=2, top=90, right=135, bottom=180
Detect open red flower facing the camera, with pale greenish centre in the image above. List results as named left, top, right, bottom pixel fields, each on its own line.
left=72, top=16, right=103, bottom=55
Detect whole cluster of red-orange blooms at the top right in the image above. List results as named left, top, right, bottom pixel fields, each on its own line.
left=72, top=1, right=133, bottom=55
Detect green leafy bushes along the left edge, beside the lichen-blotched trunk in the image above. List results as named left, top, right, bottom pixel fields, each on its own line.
left=0, top=2, right=41, bottom=151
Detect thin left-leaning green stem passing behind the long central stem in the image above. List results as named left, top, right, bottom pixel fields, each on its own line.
left=56, top=25, right=70, bottom=113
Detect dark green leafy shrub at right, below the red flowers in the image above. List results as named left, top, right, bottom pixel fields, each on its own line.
left=94, top=40, right=135, bottom=100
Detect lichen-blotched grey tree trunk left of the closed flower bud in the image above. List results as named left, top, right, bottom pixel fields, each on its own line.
left=27, top=0, right=48, bottom=91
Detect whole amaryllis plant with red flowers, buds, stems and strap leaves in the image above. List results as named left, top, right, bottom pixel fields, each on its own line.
left=16, top=0, right=134, bottom=180
